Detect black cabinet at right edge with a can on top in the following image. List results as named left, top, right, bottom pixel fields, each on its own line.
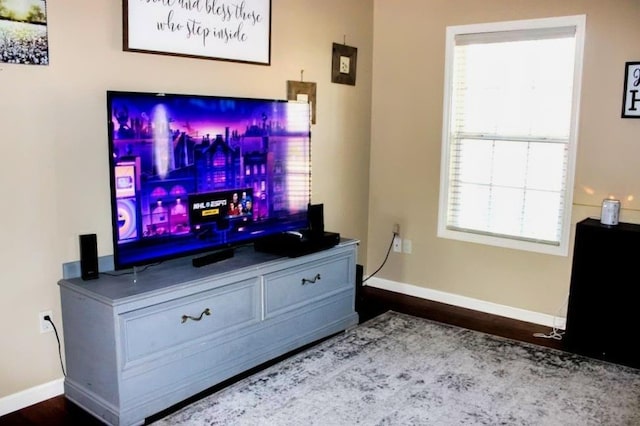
left=565, top=219, right=640, bottom=368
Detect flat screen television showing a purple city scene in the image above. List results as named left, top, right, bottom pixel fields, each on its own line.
left=107, top=91, right=311, bottom=269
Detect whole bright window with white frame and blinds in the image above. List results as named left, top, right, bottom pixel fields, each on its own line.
left=438, top=16, right=585, bottom=256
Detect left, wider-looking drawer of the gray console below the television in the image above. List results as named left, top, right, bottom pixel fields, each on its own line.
left=119, top=279, right=260, bottom=365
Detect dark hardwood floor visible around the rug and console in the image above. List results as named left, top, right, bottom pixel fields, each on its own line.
left=0, top=286, right=563, bottom=426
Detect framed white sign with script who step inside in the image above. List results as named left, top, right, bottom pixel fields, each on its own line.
left=122, top=0, right=271, bottom=65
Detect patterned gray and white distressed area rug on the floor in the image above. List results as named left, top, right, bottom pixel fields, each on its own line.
left=154, top=312, right=640, bottom=426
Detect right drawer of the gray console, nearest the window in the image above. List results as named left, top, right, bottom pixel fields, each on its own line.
left=264, top=253, right=354, bottom=317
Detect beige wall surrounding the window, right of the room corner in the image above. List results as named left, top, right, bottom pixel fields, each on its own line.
left=367, top=0, right=640, bottom=315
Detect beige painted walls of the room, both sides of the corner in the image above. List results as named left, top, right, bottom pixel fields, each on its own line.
left=5, top=0, right=640, bottom=410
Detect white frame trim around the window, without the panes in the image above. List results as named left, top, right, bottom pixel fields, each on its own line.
left=437, top=15, right=586, bottom=256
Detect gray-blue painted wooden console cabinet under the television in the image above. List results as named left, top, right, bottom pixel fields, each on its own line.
left=59, top=240, right=358, bottom=425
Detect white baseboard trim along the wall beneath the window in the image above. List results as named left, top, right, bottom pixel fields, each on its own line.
left=365, top=277, right=566, bottom=330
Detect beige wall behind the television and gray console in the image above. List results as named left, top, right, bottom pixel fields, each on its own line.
left=0, top=0, right=373, bottom=399
